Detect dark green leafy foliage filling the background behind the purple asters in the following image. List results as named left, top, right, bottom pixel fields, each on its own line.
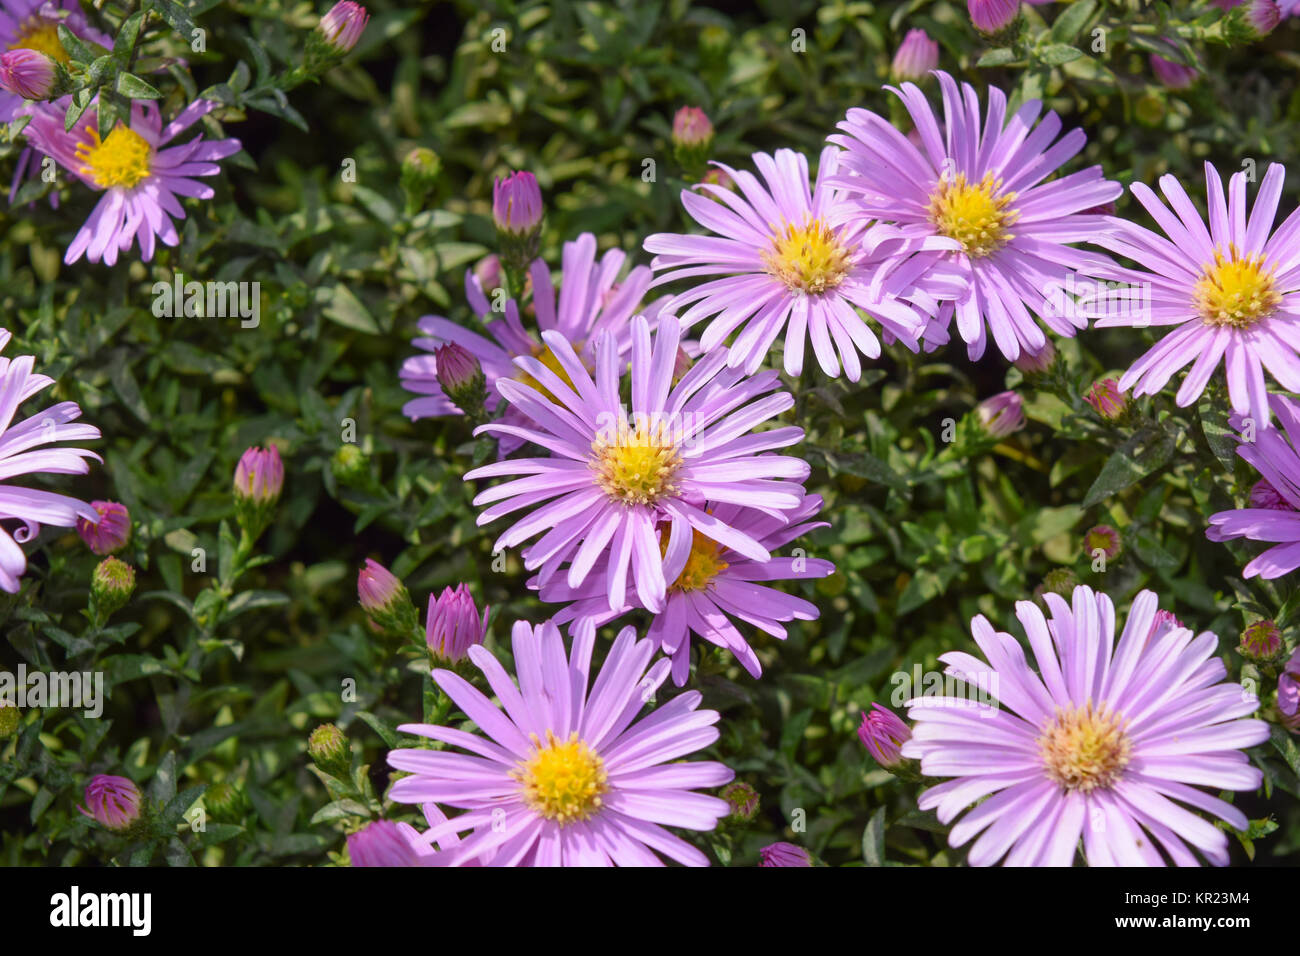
left=0, top=0, right=1300, bottom=865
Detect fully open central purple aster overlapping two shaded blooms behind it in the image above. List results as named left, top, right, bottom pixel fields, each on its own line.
left=465, top=316, right=809, bottom=614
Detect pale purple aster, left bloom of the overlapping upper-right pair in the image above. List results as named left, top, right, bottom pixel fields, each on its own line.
left=645, top=147, right=957, bottom=381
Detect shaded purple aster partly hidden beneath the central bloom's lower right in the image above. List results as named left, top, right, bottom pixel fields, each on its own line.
left=530, top=494, right=835, bottom=687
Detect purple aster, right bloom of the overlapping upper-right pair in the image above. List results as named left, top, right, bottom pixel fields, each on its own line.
left=831, top=72, right=1122, bottom=362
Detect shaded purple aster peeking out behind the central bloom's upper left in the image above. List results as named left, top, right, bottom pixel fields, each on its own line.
left=402, top=233, right=655, bottom=455
